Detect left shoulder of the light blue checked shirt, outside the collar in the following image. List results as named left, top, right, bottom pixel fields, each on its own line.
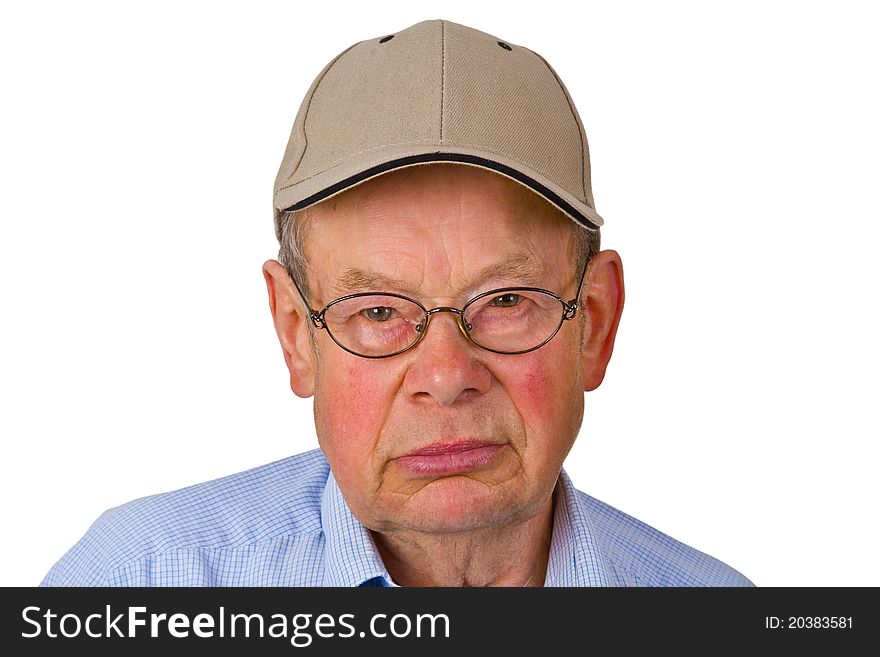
left=41, top=450, right=329, bottom=586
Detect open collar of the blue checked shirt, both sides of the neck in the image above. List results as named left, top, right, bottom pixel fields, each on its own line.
left=321, top=470, right=608, bottom=587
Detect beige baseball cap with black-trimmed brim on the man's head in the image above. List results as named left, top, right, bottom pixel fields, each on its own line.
left=273, top=20, right=603, bottom=240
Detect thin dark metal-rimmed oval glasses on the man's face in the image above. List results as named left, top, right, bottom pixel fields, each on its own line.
left=293, top=261, right=589, bottom=358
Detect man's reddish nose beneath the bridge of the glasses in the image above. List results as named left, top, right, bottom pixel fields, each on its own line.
left=403, top=312, right=492, bottom=406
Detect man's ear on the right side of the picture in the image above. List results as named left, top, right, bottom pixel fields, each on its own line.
left=581, top=250, right=623, bottom=392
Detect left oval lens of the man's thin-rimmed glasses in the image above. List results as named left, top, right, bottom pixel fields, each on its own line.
left=324, top=294, right=425, bottom=357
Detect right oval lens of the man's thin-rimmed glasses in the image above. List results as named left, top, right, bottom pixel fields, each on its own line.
left=464, top=290, right=563, bottom=352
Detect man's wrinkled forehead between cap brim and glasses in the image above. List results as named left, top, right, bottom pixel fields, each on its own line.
left=305, top=165, right=572, bottom=295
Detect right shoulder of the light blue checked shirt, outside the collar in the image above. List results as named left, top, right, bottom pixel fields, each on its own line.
left=578, top=491, right=754, bottom=586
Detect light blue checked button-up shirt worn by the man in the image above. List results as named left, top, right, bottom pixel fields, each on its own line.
left=41, top=450, right=752, bottom=587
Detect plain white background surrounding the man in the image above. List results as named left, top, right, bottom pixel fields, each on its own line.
left=0, top=0, right=880, bottom=586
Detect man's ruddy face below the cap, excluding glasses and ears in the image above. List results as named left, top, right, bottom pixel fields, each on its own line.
left=306, top=164, right=584, bottom=533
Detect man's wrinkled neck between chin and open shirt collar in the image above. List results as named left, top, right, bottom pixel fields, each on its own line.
left=372, top=498, right=554, bottom=586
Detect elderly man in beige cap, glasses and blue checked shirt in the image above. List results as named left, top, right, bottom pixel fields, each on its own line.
left=44, top=21, right=750, bottom=586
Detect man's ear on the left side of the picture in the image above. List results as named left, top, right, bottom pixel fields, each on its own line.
left=263, top=260, right=315, bottom=397
